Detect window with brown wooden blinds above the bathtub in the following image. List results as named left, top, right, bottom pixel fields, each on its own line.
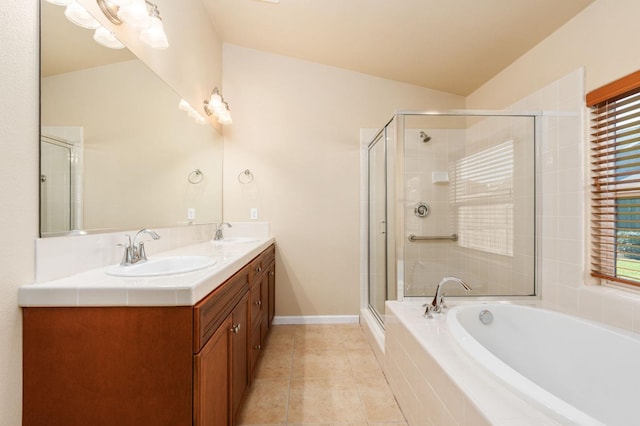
left=587, top=71, right=640, bottom=286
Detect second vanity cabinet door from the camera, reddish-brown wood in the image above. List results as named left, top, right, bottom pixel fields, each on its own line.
left=230, top=293, right=250, bottom=423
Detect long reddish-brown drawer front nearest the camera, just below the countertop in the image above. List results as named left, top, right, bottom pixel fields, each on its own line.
left=193, top=267, right=249, bottom=353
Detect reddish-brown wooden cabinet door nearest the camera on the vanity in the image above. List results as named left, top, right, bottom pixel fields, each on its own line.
left=193, top=316, right=231, bottom=426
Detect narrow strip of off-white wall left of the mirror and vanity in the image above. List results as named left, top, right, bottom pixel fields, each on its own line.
left=0, top=0, right=38, bottom=425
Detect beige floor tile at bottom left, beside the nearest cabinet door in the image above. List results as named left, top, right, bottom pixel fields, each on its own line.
left=237, top=379, right=289, bottom=425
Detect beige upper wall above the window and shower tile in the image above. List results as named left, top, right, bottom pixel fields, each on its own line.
left=467, top=0, right=640, bottom=108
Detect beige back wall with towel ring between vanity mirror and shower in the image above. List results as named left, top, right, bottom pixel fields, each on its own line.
left=223, top=44, right=464, bottom=316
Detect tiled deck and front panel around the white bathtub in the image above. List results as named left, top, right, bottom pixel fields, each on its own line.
left=384, top=302, right=559, bottom=426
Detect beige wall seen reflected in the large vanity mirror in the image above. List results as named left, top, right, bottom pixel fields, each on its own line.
left=41, top=60, right=222, bottom=229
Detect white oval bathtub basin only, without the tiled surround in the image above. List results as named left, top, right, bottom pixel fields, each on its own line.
left=447, top=303, right=640, bottom=425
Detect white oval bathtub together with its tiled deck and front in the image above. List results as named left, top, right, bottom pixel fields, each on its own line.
left=385, top=302, right=640, bottom=425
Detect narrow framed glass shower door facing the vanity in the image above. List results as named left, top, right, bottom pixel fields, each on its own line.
left=368, top=132, right=388, bottom=324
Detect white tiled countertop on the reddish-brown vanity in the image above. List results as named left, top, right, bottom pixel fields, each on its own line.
left=18, top=238, right=274, bottom=307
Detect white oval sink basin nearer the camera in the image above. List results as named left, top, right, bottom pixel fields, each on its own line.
left=106, top=256, right=217, bottom=277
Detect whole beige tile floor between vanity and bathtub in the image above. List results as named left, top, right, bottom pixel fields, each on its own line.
left=237, top=324, right=407, bottom=426
